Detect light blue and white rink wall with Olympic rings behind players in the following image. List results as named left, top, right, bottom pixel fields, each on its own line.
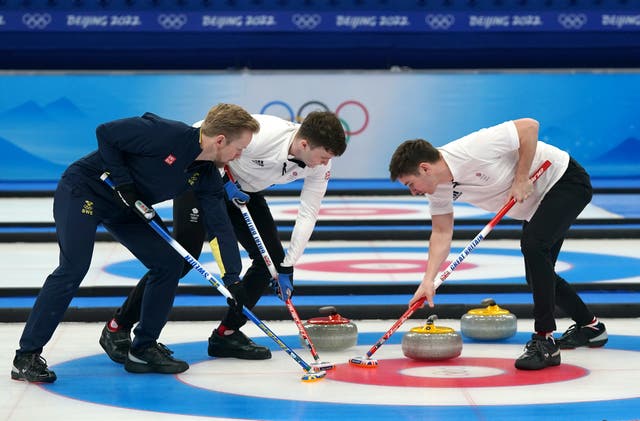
left=0, top=71, right=640, bottom=182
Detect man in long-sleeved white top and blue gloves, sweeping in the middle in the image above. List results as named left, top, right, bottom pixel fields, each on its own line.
left=100, top=111, right=346, bottom=362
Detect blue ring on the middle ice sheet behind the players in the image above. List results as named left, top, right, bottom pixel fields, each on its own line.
left=104, top=244, right=640, bottom=285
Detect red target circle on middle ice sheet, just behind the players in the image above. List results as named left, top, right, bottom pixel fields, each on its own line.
left=296, top=258, right=477, bottom=274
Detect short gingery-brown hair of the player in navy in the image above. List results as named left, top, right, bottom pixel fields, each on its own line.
left=200, top=104, right=260, bottom=143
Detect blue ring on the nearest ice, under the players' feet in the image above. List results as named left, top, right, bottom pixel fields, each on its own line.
left=42, top=332, right=640, bottom=420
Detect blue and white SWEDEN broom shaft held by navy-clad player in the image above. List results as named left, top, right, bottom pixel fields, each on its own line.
left=100, top=173, right=320, bottom=372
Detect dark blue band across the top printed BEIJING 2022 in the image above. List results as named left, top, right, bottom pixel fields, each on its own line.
left=0, top=7, right=640, bottom=70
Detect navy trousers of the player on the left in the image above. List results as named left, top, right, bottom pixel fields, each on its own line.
left=18, top=171, right=183, bottom=352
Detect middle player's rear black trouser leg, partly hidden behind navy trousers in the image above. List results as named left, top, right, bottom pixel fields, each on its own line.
left=114, top=190, right=205, bottom=330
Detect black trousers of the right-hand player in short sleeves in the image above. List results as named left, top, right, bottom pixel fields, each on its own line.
left=520, top=158, right=594, bottom=332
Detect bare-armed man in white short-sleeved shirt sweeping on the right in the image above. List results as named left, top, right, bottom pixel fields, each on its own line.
left=389, top=118, right=607, bottom=370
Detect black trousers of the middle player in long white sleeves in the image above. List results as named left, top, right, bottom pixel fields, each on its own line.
left=114, top=192, right=284, bottom=329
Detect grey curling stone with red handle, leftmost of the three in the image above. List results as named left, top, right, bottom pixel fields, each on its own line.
left=300, top=306, right=358, bottom=351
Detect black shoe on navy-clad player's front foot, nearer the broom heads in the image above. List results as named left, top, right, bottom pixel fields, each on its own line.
left=124, top=343, right=189, bottom=374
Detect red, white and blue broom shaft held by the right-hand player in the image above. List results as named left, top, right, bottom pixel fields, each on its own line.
left=352, top=161, right=551, bottom=359
